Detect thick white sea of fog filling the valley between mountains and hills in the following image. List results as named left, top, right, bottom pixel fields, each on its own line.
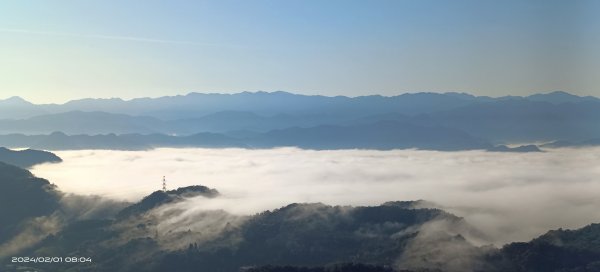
left=32, top=148, right=600, bottom=245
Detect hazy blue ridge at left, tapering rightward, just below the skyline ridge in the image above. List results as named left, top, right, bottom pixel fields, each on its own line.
left=0, top=111, right=330, bottom=135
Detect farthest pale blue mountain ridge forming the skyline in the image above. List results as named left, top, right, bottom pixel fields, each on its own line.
left=0, top=91, right=600, bottom=119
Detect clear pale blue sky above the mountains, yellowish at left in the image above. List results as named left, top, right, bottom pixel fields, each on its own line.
left=0, top=0, right=600, bottom=103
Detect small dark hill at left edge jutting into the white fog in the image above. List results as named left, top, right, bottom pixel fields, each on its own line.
left=0, top=147, right=62, bottom=168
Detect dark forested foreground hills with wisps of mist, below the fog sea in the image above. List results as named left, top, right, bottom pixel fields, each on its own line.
left=0, top=163, right=600, bottom=272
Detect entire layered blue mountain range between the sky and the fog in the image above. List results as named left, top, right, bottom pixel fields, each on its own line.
left=0, top=92, right=600, bottom=150
